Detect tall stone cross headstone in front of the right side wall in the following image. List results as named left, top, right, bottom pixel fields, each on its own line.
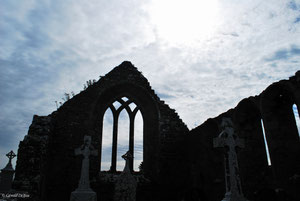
left=213, top=118, right=247, bottom=201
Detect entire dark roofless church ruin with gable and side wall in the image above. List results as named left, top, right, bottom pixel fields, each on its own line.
left=8, top=61, right=300, bottom=201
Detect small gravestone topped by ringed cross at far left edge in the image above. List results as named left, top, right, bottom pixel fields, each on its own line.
left=0, top=151, right=16, bottom=192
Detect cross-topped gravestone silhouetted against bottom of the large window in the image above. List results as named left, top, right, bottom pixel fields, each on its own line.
left=114, top=151, right=137, bottom=201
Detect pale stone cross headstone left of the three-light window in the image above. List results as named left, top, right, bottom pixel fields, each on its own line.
left=70, top=136, right=98, bottom=201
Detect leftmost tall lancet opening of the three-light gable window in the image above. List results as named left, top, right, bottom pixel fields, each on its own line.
left=101, top=108, right=113, bottom=171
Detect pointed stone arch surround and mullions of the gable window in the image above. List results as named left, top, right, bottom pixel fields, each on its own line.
left=91, top=83, right=160, bottom=178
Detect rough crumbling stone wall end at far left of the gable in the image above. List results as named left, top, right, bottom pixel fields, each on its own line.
left=13, top=114, right=55, bottom=201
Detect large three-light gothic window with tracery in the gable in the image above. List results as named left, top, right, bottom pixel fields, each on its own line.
left=101, top=97, right=143, bottom=172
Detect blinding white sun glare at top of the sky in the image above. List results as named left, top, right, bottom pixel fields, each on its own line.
left=150, top=0, right=218, bottom=44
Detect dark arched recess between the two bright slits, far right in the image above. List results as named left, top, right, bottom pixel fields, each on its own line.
left=261, top=82, right=300, bottom=184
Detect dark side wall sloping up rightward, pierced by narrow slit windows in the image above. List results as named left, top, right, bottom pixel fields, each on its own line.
left=185, top=71, right=300, bottom=201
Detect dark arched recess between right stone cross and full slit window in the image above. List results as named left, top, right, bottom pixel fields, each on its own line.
left=234, top=97, right=268, bottom=195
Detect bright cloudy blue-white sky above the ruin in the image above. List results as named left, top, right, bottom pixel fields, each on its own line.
left=0, top=0, right=300, bottom=168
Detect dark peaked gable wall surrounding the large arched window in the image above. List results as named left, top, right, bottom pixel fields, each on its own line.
left=15, top=62, right=188, bottom=201
